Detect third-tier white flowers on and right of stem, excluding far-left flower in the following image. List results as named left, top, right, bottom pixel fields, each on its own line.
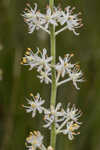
left=44, top=103, right=81, bottom=140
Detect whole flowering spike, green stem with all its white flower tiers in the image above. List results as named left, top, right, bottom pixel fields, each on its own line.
left=21, top=2, right=84, bottom=150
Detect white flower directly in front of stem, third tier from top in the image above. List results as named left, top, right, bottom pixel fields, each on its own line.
left=44, top=103, right=63, bottom=129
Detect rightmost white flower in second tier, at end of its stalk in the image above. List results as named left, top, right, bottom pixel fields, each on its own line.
left=69, top=65, right=84, bottom=90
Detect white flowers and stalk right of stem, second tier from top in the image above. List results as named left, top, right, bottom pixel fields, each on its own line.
left=55, top=54, right=84, bottom=90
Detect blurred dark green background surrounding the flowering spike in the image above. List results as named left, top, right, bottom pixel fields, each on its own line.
left=0, top=0, right=100, bottom=150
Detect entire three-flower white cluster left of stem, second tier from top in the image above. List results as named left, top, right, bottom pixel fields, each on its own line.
left=21, top=48, right=52, bottom=84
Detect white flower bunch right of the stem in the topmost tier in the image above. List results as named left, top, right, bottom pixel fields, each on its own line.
left=59, top=6, right=82, bottom=35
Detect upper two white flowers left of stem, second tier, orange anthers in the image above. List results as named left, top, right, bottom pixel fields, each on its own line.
left=22, top=48, right=52, bottom=72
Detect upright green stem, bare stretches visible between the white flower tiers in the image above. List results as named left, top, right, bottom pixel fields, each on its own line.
left=49, top=0, right=57, bottom=150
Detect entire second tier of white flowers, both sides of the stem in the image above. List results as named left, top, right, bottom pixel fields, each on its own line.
left=21, top=48, right=84, bottom=90
